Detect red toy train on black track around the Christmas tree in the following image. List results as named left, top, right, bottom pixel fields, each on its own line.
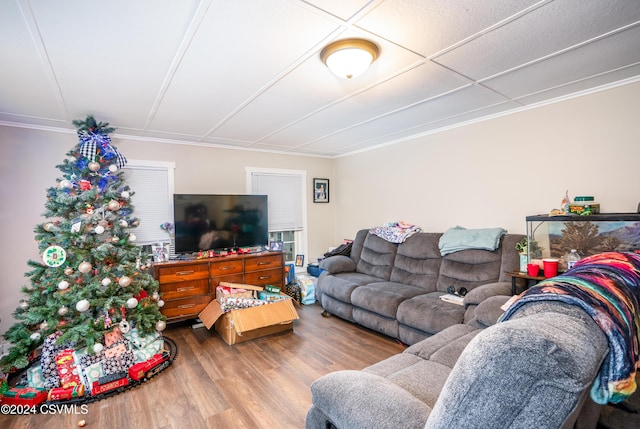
left=0, top=337, right=178, bottom=409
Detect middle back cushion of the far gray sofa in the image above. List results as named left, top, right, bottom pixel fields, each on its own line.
left=391, top=232, right=442, bottom=292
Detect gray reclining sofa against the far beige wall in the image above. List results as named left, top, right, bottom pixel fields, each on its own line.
left=316, top=230, right=524, bottom=345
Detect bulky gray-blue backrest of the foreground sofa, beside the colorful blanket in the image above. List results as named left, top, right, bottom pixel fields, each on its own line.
left=425, top=307, right=607, bottom=429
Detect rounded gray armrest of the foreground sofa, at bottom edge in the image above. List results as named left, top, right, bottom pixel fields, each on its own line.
left=311, top=370, right=431, bottom=429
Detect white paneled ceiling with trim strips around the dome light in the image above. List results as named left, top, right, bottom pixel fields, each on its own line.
left=0, top=0, right=640, bottom=157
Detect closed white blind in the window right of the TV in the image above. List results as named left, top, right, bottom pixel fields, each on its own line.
left=251, top=172, right=304, bottom=232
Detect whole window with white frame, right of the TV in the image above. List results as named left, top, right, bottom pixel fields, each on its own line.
left=246, top=167, right=307, bottom=264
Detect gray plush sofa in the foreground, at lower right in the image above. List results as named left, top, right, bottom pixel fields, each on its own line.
left=306, top=296, right=609, bottom=429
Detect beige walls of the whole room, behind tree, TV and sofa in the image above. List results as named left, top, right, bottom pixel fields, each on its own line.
left=0, top=83, right=640, bottom=332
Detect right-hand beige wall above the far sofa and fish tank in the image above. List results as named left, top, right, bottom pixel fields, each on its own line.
left=333, top=83, right=640, bottom=239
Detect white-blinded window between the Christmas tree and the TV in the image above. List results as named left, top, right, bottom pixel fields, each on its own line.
left=123, top=160, right=175, bottom=245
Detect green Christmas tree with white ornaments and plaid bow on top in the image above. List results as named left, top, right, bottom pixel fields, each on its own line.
left=0, top=116, right=166, bottom=370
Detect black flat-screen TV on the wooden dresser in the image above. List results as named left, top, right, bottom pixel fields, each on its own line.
left=173, top=194, right=269, bottom=253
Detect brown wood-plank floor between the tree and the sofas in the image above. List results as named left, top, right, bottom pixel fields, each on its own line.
left=0, top=304, right=404, bottom=429
